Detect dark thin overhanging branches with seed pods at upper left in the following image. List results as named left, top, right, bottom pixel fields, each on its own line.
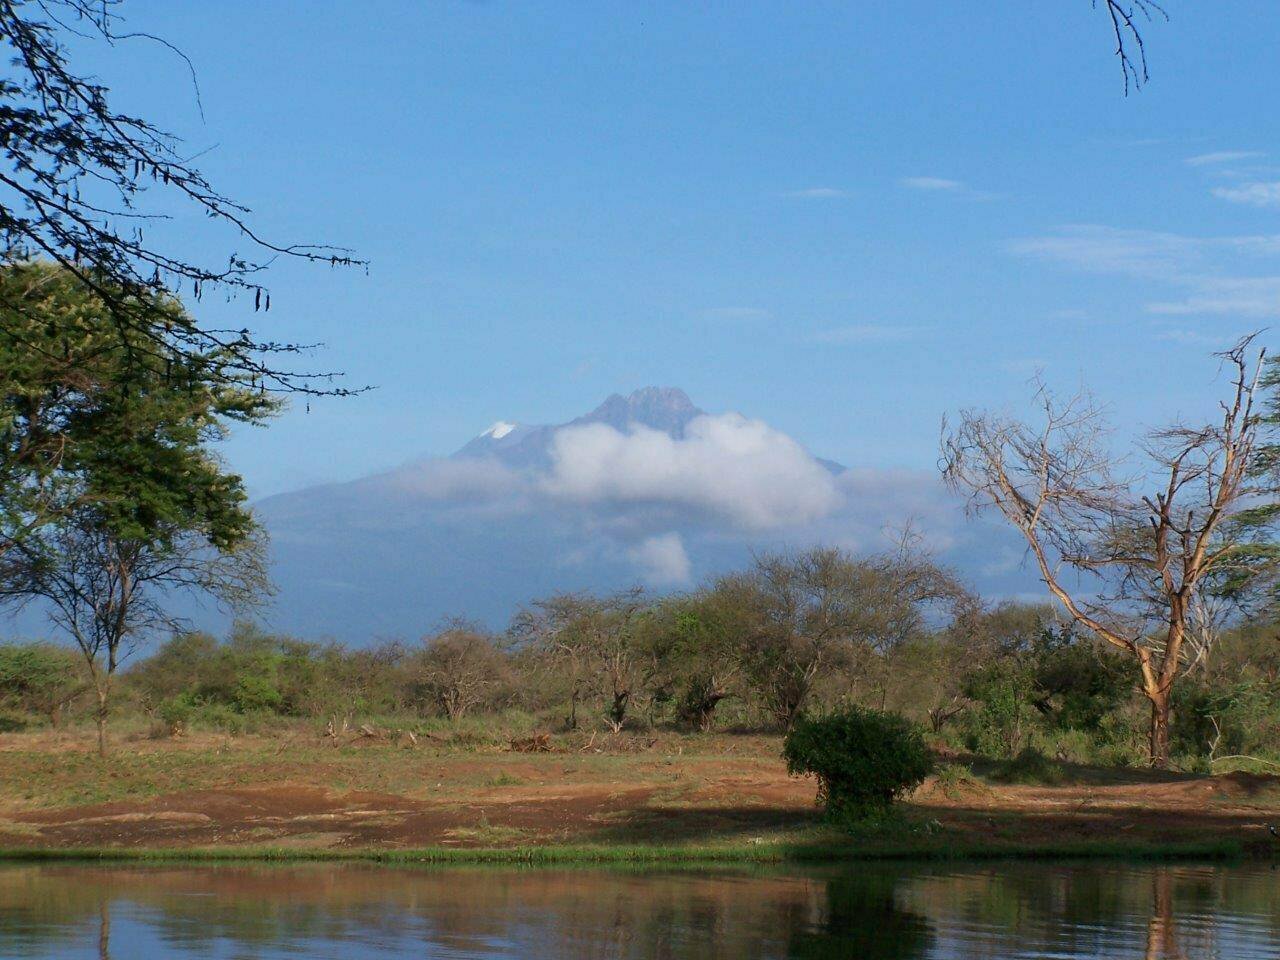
left=0, top=0, right=360, bottom=393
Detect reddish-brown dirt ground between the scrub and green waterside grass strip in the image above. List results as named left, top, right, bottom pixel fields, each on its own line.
left=0, top=735, right=1280, bottom=851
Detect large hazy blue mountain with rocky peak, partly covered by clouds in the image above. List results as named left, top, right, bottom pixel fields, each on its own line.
left=244, top=387, right=1027, bottom=643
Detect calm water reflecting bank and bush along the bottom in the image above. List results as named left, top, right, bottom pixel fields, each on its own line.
left=0, top=864, right=1280, bottom=960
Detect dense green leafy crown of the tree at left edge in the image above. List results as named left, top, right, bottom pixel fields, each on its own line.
left=0, top=261, right=279, bottom=553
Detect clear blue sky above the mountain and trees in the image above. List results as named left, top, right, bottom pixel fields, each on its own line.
left=77, top=0, right=1280, bottom=495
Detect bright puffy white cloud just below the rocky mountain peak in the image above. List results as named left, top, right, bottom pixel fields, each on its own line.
left=543, top=413, right=841, bottom=529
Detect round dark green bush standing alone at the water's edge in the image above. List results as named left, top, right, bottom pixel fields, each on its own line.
left=782, top=707, right=933, bottom=822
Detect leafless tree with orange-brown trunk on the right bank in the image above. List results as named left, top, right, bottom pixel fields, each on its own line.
left=942, top=338, right=1274, bottom=767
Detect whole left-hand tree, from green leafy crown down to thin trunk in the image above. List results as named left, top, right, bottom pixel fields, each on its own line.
left=0, top=266, right=278, bottom=753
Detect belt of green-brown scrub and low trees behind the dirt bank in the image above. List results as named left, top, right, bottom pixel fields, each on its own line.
left=0, top=550, right=1280, bottom=772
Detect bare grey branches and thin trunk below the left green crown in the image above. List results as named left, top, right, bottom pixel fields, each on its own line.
left=0, top=521, right=270, bottom=756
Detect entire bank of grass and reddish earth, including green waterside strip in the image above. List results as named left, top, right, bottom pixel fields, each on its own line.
left=0, top=728, right=1280, bottom=864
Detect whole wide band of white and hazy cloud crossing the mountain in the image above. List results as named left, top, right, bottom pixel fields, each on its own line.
left=335, top=413, right=983, bottom=589
